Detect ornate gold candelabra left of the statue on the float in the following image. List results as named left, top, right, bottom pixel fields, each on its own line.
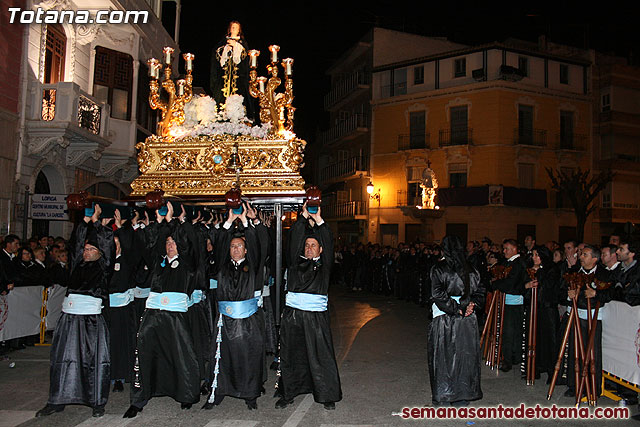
left=147, top=47, right=195, bottom=137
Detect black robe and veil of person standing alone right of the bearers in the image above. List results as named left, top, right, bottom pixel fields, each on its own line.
left=428, top=261, right=485, bottom=403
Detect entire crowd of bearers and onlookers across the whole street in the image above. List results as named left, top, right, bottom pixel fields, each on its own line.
left=0, top=213, right=640, bottom=417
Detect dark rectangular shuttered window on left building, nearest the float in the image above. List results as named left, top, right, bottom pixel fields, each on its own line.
left=93, top=46, right=133, bottom=120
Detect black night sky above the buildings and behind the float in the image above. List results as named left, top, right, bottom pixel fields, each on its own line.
left=164, top=0, right=640, bottom=142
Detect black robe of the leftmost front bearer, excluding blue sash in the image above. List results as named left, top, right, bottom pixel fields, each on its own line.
left=48, top=222, right=114, bottom=407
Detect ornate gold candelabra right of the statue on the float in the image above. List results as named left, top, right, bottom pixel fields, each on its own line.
left=249, top=45, right=295, bottom=134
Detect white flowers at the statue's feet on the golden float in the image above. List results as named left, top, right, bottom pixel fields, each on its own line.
left=171, top=95, right=271, bottom=139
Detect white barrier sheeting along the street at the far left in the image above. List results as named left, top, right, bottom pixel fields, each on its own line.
left=0, top=285, right=67, bottom=341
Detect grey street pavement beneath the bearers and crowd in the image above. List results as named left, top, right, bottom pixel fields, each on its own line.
left=0, top=289, right=640, bottom=427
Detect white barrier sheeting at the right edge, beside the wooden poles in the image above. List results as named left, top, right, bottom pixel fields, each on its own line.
left=602, top=301, right=640, bottom=385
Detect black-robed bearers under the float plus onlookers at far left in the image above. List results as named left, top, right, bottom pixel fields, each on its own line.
left=0, top=203, right=342, bottom=418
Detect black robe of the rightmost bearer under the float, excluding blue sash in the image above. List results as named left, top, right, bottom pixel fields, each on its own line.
left=278, top=216, right=342, bottom=403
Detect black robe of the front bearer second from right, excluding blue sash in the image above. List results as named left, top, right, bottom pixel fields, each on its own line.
left=209, top=225, right=266, bottom=401
